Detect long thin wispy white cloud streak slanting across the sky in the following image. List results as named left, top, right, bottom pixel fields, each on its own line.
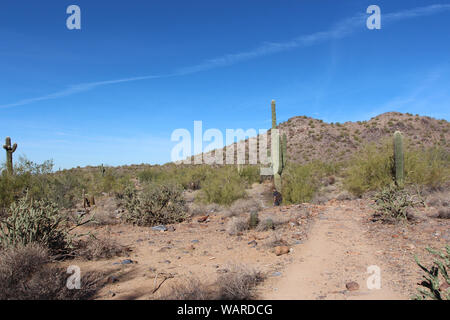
left=0, top=4, right=450, bottom=109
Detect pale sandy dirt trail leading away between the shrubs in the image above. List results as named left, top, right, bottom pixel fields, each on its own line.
left=260, top=202, right=409, bottom=300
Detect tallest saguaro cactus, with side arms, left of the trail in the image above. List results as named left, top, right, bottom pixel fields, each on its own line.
left=270, top=100, right=287, bottom=192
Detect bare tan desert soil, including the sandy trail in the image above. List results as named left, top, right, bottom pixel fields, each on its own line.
left=66, top=185, right=450, bottom=299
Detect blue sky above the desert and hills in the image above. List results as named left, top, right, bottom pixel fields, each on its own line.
left=0, top=0, right=450, bottom=168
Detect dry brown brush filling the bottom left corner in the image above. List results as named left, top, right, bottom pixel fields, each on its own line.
left=0, top=244, right=101, bottom=300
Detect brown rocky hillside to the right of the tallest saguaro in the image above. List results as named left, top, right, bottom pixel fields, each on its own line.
left=202, top=112, right=450, bottom=163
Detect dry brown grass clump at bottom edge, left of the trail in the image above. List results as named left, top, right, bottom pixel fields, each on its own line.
left=162, top=265, right=265, bottom=300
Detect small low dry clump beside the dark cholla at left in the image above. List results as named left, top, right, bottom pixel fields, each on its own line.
left=75, top=236, right=130, bottom=260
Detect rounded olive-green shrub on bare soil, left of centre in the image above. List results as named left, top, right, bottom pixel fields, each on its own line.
left=123, top=182, right=187, bottom=226
